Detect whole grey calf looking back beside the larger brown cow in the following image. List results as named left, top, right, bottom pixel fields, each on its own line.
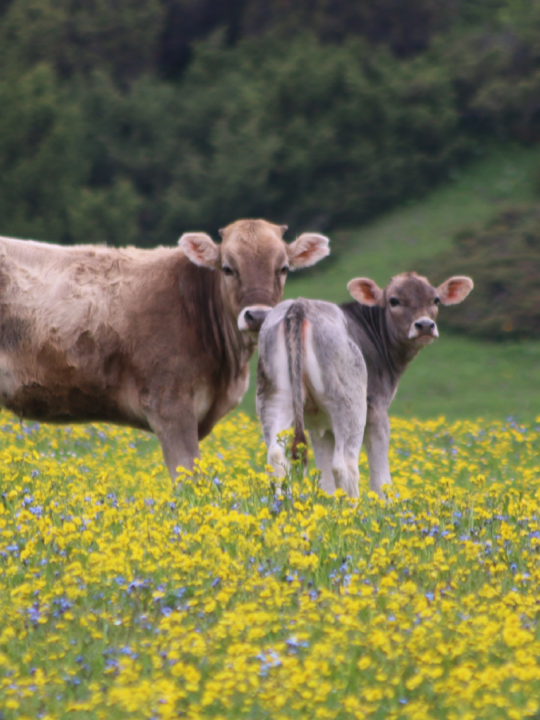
left=257, top=273, right=472, bottom=497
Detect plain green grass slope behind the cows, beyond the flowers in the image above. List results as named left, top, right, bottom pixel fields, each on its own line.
left=242, top=146, right=540, bottom=420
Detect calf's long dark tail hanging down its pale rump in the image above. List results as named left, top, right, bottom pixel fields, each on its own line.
left=285, top=302, right=307, bottom=466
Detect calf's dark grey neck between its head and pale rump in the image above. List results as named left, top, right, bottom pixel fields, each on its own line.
left=341, top=302, right=420, bottom=391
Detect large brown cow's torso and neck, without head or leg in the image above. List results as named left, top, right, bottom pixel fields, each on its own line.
left=0, top=238, right=245, bottom=430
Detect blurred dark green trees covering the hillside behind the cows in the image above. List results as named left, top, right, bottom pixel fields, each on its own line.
left=0, top=0, right=540, bottom=246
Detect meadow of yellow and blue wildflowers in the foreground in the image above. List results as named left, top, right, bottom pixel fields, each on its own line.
left=0, top=415, right=540, bottom=720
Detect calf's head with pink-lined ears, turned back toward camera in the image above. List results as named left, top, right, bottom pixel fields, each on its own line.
left=347, top=273, right=473, bottom=347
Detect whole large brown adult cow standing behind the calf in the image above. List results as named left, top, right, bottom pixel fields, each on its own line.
left=0, top=220, right=329, bottom=476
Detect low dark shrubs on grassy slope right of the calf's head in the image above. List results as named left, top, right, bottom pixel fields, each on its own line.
left=422, top=206, right=540, bottom=340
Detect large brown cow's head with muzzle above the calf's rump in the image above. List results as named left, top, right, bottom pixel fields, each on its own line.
left=179, top=220, right=330, bottom=332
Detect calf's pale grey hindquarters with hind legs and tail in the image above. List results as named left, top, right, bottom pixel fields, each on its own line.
left=257, top=298, right=368, bottom=496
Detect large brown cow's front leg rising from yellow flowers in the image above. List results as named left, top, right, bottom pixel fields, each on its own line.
left=147, top=400, right=201, bottom=480
